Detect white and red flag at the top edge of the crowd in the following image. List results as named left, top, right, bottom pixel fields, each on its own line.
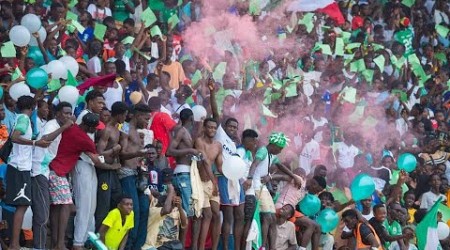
left=287, top=0, right=345, bottom=25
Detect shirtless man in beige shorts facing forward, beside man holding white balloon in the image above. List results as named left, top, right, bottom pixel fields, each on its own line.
left=192, top=118, right=222, bottom=250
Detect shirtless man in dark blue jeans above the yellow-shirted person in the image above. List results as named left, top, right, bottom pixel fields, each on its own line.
left=119, top=104, right=150, bottom=249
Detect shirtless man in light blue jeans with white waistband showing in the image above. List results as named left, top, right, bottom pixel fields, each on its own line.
left=167, top=109, right=199, bottom=246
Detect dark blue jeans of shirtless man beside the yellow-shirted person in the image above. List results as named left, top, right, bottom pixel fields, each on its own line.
left=120, top=175, right=149, bottom=250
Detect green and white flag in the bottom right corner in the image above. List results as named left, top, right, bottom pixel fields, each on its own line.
left=416, top=198, right=442, bottom=250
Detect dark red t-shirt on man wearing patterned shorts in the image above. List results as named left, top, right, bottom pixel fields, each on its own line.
left=50, top=124, right=97, bottom=176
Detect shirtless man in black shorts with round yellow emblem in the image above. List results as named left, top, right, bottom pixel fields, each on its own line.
left=95, top=102, right=128, bottom=230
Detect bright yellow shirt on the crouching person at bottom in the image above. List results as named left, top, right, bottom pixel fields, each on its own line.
left=103, top=208, right=134, bottom=250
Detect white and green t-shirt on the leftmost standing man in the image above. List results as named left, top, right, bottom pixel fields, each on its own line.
left=8, top=114, right=33, bottom=171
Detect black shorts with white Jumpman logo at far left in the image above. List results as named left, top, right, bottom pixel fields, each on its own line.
left=5, top=165, right=31, bottom=206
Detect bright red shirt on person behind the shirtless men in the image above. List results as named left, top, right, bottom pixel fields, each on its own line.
left=150, top=112, right=177, bottom=154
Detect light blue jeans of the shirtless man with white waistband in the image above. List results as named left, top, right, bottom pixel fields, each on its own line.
left=172, top=173, right=194, bottom=217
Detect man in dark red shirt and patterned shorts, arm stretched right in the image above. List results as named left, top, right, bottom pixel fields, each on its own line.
left=49, top=113, right=120, bottom=249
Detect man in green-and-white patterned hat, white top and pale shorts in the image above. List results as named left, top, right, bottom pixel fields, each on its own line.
left=243, top=132, right=302, bottom=249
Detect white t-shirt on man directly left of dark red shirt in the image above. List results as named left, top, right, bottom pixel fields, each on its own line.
left=31, top=119, right=62, bottom=179
